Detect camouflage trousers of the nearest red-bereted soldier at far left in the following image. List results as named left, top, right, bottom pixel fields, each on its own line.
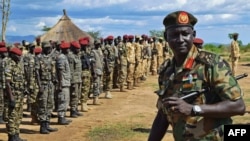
left=4, top=91, right=23, bottom=135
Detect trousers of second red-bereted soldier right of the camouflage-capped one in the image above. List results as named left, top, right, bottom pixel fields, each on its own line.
left=69, top=82, right=82, bottom=110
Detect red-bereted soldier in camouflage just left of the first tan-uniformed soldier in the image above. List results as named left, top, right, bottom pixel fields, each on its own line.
left=103, top=35, right=116, bottom=99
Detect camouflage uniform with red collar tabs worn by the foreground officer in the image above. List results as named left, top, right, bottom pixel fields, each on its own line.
left=158, top=46, right=243, bottom=141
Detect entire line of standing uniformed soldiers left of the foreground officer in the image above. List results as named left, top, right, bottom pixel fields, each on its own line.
left=0, top=35, right=170, bottom=140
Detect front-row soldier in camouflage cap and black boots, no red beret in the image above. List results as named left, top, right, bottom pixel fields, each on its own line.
left=35, top=42, right=58, bottom=134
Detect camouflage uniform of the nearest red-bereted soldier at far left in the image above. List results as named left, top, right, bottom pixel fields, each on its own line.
left=5, top=60, right=24, bottom=135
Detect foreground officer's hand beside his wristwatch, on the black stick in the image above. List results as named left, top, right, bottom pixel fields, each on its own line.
left=162, top=97, right=193, bottom=116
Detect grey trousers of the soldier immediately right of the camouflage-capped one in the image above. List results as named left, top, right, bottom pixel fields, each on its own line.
left=57, top=86, right=70, bottom=117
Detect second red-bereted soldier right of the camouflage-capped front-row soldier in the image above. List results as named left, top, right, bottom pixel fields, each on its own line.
left=67, top=41, right=83, bottom=115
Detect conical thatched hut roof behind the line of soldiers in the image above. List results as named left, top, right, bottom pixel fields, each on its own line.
left=40, top=9, right=94, bottom=43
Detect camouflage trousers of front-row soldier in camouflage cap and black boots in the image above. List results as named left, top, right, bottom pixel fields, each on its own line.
left=37, top=82, right=54, bottom=121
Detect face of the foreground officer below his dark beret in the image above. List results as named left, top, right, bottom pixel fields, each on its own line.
left=165, top=26, right=195, bottom=56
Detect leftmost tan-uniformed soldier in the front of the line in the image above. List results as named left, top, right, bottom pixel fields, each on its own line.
left=117, top=35, right=128, bottom=92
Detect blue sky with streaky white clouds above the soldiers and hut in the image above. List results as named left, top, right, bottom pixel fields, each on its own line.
left=6, top=0, right=250, bottom=44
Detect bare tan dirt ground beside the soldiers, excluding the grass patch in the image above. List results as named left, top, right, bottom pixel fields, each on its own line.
left=0, top=63, right=250, bottom=141
